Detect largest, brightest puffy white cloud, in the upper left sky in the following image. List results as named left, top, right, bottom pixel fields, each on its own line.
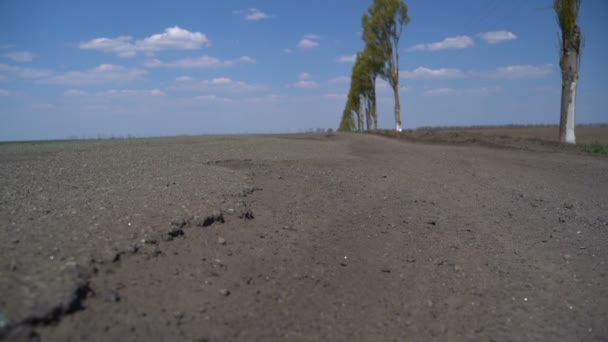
left=80, top=26, right=211, bottom=58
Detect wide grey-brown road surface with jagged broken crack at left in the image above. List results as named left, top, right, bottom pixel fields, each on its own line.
left=0, top=134, right=608, bottom=341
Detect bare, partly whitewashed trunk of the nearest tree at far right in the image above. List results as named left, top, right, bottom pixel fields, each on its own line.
left=559, top=49, right=578, bottom=144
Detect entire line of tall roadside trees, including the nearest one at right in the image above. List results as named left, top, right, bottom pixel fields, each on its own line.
left=339, top=0, right=582, bottom=144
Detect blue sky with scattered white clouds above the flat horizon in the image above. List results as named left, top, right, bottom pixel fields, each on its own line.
left=0, top=0, right=608, bottom=140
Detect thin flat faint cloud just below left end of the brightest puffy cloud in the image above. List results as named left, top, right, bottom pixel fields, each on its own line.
left=39, top=64, right=147, bottom=85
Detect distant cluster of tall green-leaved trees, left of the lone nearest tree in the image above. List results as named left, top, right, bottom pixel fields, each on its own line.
left=339, top=0, right=410, bottom=131
